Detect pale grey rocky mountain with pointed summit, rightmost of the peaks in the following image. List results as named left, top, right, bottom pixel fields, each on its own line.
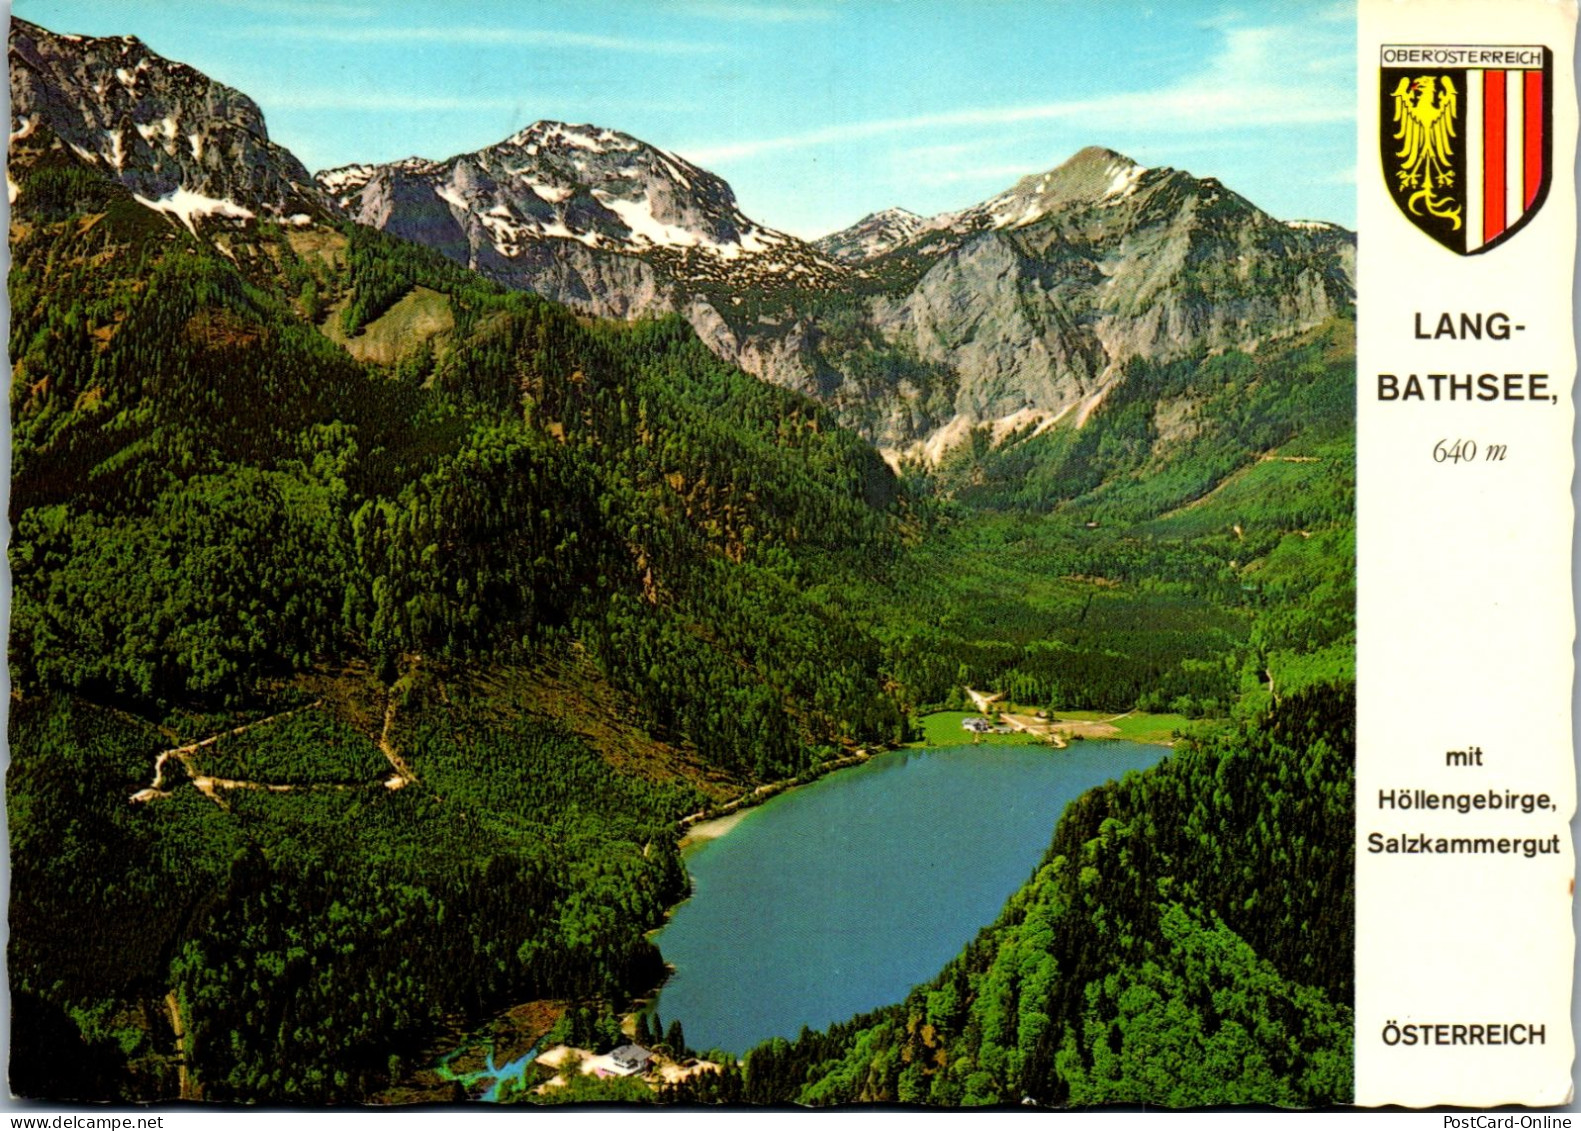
left=841, top=149, right=1355, bottom=457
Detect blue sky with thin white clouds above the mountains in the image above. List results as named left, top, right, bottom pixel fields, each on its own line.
left=14, top=0, right=1355, bottom=236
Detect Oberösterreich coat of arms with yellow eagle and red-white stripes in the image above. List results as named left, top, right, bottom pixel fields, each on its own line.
left=1380, top=44, right=1553, bottom=255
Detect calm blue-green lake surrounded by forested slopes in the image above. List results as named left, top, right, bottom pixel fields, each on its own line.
left=656, top=742, right=1168, bottom=1053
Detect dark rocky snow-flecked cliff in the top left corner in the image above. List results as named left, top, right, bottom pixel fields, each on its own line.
left=9, top=17, right=327, bottom=223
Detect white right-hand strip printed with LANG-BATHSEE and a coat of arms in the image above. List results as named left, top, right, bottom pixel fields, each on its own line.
left=1355, top=5, right=1575, bottom=1106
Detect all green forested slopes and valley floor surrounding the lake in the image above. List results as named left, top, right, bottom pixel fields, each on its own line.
left=8, top=108, right=1353, bottom=1103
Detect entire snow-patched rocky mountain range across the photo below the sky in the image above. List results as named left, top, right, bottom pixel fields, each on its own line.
left=11, top=21, right=1355, bottom=465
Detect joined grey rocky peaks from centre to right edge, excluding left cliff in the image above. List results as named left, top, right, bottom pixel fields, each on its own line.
left=319, top=122, right=1353, bottom=459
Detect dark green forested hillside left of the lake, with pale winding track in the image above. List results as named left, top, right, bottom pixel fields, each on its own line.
left=8, top=134, right=904, bottom=1099
